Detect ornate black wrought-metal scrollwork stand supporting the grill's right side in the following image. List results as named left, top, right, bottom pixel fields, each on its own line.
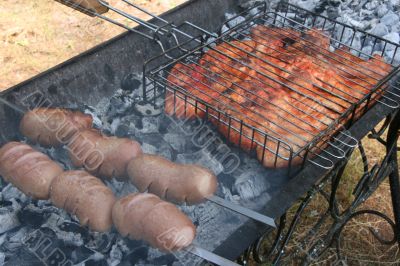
left=236, top=110, right=400, bottom=265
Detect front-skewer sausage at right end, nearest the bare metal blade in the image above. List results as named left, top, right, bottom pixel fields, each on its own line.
left=112, top=193, right=196, bottom=251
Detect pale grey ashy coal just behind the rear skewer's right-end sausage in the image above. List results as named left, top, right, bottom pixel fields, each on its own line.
left=176, top=149, right=224, bottom=175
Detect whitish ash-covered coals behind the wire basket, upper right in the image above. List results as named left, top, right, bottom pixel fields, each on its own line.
left=236, top=0, right=400, bottom=65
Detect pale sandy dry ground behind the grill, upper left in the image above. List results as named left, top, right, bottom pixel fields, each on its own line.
left=0, top=0, right=185, bottom=91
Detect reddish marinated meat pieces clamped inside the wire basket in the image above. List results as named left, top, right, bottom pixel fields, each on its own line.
left=165, top=25, right=391, bottom=167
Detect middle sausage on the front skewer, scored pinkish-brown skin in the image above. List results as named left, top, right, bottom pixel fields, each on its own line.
left=50, top=171, right=116, bottom=232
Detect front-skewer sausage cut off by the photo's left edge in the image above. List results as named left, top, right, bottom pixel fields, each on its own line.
left=0, top=142, right=63, bottom=200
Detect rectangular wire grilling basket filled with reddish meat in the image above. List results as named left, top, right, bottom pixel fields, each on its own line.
left=144, top=4, right=400, bottom=171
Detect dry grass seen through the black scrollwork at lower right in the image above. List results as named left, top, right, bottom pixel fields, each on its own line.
left=262, top=127, right=400, bottom=265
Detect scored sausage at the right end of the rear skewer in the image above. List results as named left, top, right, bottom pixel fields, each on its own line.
left=127, top=154, right=217, bottom=204
